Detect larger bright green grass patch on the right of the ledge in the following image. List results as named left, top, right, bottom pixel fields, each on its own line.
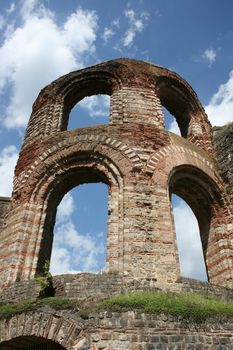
left=98, top=292, right=233, bottom=322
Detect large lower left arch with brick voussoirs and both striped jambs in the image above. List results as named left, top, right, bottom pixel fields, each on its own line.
left=8, top=135, right=138, bottom=279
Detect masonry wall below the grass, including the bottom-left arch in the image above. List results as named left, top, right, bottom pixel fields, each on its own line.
left=0, top=308, right=233, bottom=350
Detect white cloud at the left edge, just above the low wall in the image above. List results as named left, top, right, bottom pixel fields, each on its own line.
left=0, top=145, right=18, bottom=197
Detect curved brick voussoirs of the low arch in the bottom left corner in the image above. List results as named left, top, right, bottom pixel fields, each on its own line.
left=0, top=311, right=86, bottom=350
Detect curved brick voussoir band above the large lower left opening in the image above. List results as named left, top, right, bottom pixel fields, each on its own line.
left=14, top=135, right=141, bottom=202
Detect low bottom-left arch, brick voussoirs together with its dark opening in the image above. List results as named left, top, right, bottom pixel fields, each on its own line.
left=0, top=311, right=84, bottom=350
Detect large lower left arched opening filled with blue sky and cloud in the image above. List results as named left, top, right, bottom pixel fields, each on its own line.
left=50, top=183, right=108, bottom=275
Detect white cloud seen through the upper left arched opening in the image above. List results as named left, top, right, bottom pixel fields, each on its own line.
left=79, top=95, right=110, bottom=118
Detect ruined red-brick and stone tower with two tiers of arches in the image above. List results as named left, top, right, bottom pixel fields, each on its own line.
left=0, top=59, right=233, bottom=350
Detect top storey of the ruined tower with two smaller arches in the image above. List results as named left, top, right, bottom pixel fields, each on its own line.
left=24, top=59, right=212, bottom=151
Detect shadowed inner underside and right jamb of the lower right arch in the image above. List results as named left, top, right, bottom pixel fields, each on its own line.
left=168, top=164, right=231, bottom=284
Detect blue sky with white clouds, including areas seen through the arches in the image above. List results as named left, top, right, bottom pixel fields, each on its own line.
left=0, top=0, right=233, bottom=280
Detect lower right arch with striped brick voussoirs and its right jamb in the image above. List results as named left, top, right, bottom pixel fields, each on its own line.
left=147, top=146, right=232, bottom=285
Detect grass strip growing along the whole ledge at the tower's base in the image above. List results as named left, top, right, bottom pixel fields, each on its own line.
left=0, top=292, right=233, bottom=322
